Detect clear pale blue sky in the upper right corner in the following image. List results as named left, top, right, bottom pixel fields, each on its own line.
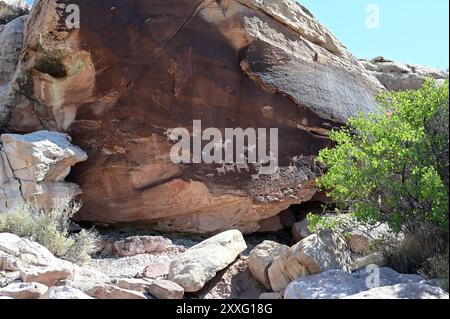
left=28, top=0, right=449, bottom=69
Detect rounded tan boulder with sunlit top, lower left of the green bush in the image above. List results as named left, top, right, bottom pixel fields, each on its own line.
left=268, top=231, right=352, bottom=292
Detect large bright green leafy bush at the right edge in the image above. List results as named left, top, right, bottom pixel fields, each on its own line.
left=318, top=80, right=449, bottom=232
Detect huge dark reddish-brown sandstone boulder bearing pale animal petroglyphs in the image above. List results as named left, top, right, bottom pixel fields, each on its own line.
left=1, top=0, right=382, bottom=233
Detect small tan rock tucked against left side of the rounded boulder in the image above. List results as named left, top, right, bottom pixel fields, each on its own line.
left=248, top=240, right=289, bottom=290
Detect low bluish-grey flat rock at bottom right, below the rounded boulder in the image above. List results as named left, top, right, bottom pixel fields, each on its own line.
left=284, top=268, right=424, bottom=299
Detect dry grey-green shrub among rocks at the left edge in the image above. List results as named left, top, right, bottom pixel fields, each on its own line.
left=0, top=198, right=98, bottom=263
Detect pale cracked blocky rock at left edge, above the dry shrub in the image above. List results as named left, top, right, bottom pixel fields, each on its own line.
left=0, top=131, right=87, bottom=213
